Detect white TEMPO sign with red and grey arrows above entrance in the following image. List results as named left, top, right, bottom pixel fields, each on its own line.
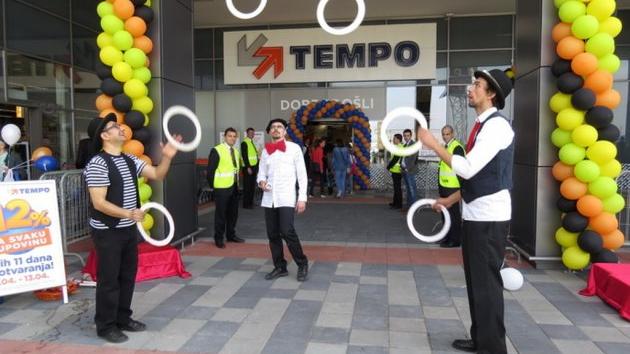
left=223, top=23, right=436, bottom=85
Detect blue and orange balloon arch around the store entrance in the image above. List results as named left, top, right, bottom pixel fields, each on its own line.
left=288, top=100, right=372, bottom=189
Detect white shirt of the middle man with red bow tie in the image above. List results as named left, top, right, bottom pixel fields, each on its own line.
left=256, top=141, right=308, bottom=208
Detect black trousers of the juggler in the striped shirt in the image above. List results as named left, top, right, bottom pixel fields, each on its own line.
left=92, top=225, right=138, bottom=335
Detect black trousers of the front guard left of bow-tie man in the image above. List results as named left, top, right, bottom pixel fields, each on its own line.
left=214, top=185, right=238, bottom=241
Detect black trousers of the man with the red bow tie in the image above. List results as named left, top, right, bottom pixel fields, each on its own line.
left=265, top=207, right=308, bottom=269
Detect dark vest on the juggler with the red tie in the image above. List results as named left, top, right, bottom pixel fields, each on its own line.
left=460, top=112, right=514, bottom=203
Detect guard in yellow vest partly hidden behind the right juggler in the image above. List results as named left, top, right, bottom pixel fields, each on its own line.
left=438, top=125, right=465, bottom=248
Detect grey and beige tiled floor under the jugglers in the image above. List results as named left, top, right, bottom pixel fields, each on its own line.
left=0, top=204, right=630, bottom=354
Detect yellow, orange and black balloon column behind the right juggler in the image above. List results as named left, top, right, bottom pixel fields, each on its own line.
left=549, top=0, right=625, bottom=269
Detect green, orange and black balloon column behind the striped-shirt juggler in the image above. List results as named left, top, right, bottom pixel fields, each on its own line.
left=96, top=0, right=154, bottom=238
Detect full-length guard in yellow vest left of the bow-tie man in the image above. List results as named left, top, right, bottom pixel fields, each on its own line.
left=208, top=127, right=245, bottom=248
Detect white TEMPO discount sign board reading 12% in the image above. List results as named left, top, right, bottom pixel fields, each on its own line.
left=0, top=180, right=66, bottom=296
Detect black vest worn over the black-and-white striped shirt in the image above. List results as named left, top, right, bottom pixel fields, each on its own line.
left=90, top=152, right=140, bottom=228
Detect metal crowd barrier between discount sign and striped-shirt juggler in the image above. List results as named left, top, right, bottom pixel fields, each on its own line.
left=39, top=170, right=90, bottom=264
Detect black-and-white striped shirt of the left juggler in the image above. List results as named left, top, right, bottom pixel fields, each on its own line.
left=83, top=154, right=146, bottom=230
